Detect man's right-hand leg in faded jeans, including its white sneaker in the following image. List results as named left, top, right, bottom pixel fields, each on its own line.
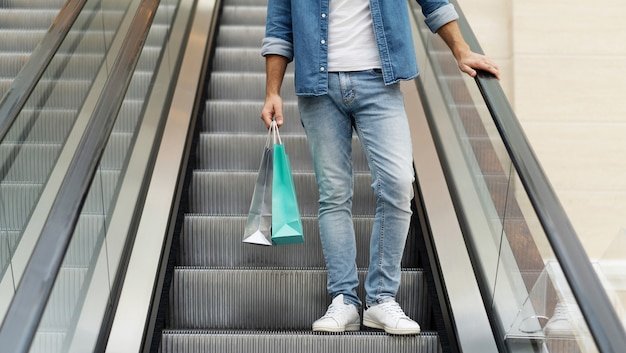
left=344, top=71, right=420, bottom=335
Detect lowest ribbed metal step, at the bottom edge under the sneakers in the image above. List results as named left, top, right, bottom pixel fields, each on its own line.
left=161, top=330, right=441, bottom=353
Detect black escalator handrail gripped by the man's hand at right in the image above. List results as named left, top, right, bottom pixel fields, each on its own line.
left=450, top=0, right=626, bottom=353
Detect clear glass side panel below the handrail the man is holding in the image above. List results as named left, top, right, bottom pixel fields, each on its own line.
left=411, top=4, right=597, bottom=353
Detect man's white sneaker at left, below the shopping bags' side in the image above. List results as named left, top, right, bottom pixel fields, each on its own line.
left=313, top=294, right=361, bottom=332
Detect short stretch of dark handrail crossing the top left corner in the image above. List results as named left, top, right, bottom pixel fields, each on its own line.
left=0, top=0, right=87, bottom=141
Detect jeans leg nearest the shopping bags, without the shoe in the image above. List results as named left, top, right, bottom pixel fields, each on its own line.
left=298, top=74, right=361, bottom=307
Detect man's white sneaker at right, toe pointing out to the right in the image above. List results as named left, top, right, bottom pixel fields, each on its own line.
left=363, top=299, right=420, bottom=335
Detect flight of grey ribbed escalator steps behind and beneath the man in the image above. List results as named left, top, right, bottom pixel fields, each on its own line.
left=155, top=0, right=440, bottom=352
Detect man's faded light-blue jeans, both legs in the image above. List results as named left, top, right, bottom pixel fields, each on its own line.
left=298, top=70, right=414, bottom=307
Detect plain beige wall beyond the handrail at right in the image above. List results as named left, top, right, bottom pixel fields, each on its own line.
left=459, top=0, right=626, bottom=259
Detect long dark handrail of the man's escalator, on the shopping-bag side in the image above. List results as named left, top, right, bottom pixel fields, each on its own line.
left=0, top=0, right=160, bottom=353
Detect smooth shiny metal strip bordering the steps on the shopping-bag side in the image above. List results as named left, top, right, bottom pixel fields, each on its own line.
left=106, top=0, right=217, bottom=353
